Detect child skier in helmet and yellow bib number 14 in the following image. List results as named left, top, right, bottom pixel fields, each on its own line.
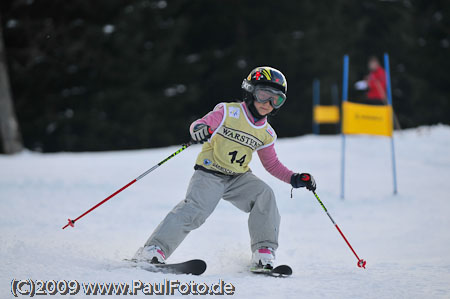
left=134, top=67, right=316, bottom=269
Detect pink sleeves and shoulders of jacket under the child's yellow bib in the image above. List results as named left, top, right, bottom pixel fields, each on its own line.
left=190, top=103, right=294, bottom=184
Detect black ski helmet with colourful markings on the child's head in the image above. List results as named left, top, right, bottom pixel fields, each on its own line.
left=241, top=66, right=287, bottom=116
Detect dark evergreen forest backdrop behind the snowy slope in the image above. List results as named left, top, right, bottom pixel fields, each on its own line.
left=0, top=0, right=450, bottom=152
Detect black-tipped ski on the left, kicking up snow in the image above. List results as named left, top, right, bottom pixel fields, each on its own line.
left=125, top=259, right=206, bottom=275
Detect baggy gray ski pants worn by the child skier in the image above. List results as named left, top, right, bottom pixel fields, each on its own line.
left=145, top=170, right=280, bottom=257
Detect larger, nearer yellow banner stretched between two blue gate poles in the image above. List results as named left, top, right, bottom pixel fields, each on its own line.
left=342, top=101, right=392, bottom=137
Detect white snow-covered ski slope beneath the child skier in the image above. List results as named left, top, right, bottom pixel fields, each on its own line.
left=0, top=125, right=450, bottom=298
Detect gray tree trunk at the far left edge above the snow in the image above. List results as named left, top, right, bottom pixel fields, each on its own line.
left=0, top=19, right=23, bottom=154
